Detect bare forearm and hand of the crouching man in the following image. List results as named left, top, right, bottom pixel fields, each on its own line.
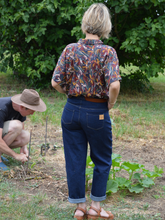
left=0, top=128, right=28, bottom=163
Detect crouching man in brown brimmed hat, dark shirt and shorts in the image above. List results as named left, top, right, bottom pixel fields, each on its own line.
left=0, top=89, right=46, bottom=171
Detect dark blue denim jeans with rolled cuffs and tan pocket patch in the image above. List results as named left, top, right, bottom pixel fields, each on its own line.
left=61, top=97, right=112, bottom=203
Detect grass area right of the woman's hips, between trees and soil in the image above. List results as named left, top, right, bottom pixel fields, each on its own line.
left=110, top=75, right=165, bottom=139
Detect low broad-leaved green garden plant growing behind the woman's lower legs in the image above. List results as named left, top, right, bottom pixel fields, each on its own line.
left=86, top=154, right=163, bottom=194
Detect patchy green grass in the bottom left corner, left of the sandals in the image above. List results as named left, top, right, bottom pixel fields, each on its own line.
left=0, top=179, right=73, bottom=220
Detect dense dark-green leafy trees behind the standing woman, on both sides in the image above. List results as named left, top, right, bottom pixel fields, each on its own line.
left=0, top=0, right=165, bottom=87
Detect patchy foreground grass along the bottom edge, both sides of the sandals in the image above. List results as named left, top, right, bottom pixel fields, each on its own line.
left=0, top=181, right=161, bottom=220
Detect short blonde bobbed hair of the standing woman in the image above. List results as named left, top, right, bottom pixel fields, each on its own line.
left=81, top=3, right=112, bottom=38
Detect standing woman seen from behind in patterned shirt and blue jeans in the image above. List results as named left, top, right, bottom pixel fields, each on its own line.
left=52, top=3, right=121, bottom=220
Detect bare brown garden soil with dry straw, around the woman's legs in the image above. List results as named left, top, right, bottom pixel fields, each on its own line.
left=1, top=117, right=165, bottom=219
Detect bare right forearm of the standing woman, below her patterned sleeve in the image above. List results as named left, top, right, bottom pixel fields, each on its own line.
left=108, top=81, right=120, bottom=110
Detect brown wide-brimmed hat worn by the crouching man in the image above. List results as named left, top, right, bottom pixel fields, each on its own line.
left=11, top=89, right=46, bottom=112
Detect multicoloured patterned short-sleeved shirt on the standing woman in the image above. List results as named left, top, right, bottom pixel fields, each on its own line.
left=52, top=39, right=121, bottom=99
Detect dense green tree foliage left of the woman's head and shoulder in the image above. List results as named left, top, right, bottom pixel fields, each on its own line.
left=0, top=0, right=75, bottom=88
